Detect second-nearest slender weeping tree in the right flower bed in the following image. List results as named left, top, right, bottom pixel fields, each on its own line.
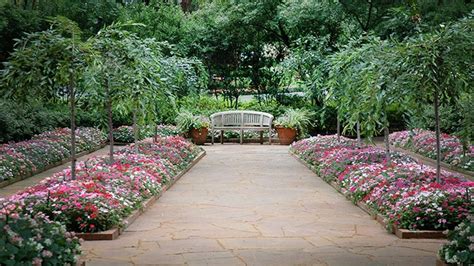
left=344, top=38, right=404, bottom=164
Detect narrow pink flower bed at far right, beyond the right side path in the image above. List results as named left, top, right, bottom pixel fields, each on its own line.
left=390, top=129, right=474, bottom=171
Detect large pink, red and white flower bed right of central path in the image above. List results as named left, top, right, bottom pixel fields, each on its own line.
left=290, top=136, right=474, bottom=233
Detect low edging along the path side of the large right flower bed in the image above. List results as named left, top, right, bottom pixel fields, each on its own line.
left=289, top=151, right=446, bottom=239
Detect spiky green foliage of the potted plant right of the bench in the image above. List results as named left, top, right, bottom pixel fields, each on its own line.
left=274, top=108, right=314, bottom=137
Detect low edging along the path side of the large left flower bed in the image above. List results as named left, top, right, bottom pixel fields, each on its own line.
left=76, top=150, right=206, bottom=241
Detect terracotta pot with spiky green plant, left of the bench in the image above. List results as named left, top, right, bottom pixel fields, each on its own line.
left=176, top=111, right=210, bottom=145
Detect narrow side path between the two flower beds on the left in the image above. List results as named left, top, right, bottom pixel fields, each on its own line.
left=0, top=145, right=123, bottom=198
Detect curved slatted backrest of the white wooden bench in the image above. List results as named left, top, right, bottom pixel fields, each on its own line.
left=211, top=111, right=273, bottom=128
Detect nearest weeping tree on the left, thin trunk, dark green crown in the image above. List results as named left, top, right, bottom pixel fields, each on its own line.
left=3, top=17, right=93, bottom=179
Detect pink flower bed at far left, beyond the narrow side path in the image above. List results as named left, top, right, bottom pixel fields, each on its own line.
left=0, top=128, right=105, bottom=182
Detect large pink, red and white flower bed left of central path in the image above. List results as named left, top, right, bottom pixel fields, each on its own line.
left=0, top=137, right=200, bottom=232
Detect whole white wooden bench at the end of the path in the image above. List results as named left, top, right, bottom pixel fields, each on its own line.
left=211, top=111, right=273, bottom=144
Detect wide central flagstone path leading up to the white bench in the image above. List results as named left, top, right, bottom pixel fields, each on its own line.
left=83, top=144, right=442, bottom=265
